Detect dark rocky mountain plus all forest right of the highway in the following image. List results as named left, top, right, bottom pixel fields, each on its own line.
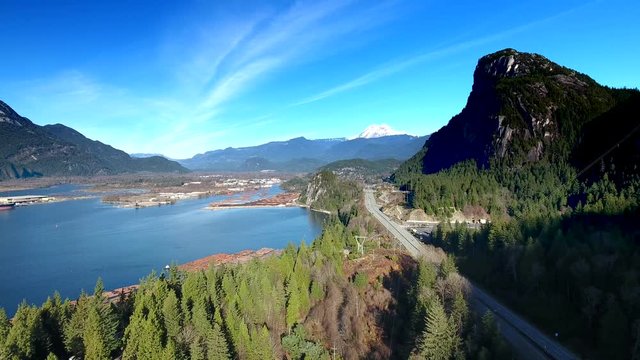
left=394, top=49, right=640, bottom=359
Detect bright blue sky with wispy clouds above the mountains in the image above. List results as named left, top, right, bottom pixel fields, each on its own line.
left=0, top=0, right=640, bottom=158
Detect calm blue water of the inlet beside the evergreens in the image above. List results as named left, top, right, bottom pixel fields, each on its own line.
left=0, top=186, right=323, bottom=314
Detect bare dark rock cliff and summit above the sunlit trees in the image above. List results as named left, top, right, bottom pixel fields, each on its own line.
left=414, top=49, right=616, bottom=173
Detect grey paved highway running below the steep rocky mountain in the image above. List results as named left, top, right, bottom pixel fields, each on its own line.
left=365, top=189, right=578, bottom=360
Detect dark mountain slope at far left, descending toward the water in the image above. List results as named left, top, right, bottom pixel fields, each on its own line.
left=0, top=101, right=188, bottom=180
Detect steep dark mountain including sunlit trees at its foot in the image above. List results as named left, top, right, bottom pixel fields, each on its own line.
left=394, top=49, right=640, bottom=216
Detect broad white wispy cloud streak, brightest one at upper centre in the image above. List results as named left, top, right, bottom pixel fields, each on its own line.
left=189, top=1, right=396, bottom=121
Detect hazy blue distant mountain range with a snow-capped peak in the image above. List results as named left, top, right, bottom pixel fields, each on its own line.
left=178, top=131, right=428, bottom=172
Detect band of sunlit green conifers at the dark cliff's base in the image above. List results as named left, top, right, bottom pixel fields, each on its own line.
left=394, top=160, right=577, bottom=218
